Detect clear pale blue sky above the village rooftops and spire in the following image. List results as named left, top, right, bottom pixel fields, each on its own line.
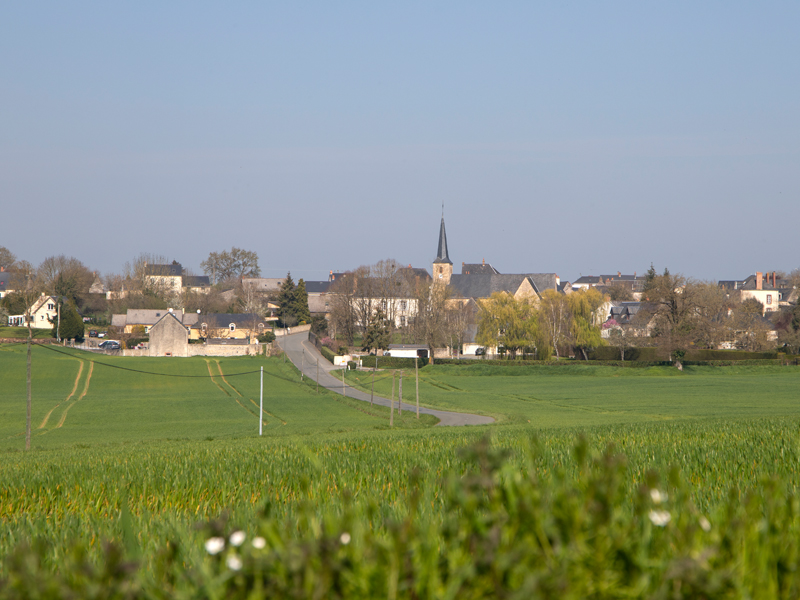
left=0, top=0, right=800, bottom=281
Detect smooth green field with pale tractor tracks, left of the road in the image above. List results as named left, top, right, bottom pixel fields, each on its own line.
left=0, top=346, right=435, bottom=451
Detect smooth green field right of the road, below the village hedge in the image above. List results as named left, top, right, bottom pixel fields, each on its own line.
left=348, top=363, right=800, bottom=427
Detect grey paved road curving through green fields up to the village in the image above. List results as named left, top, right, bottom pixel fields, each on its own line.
left=278, top=332, right=494, bottom=426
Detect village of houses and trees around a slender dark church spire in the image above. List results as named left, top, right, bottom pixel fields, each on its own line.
left=0, top=216, right=800, bottom=364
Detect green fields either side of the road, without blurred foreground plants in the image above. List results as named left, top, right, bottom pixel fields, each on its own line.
left=0, top=346, right=800, bottom=597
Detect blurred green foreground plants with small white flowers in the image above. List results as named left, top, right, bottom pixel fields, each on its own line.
left=0, top=439, right=800, bottom=599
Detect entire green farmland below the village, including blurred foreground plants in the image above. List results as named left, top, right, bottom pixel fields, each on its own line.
left=0, top=347, right=800, bottom=598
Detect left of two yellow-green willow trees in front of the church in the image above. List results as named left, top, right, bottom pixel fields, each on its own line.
left=476, top=292, right=549, bottom=358
